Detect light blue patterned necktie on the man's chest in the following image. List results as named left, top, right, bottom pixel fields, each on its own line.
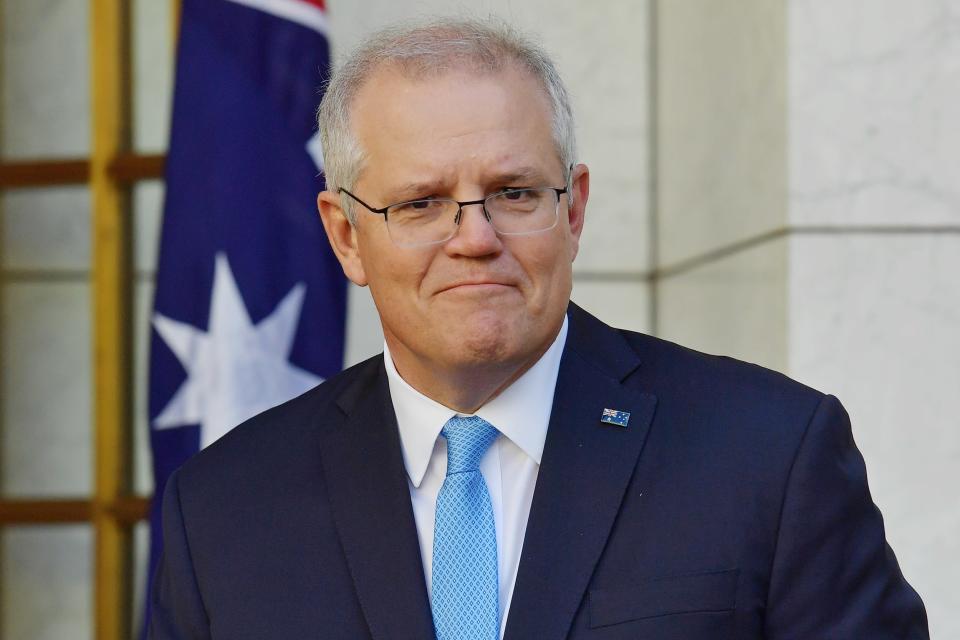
left=433, top=416, right=500, bottom=640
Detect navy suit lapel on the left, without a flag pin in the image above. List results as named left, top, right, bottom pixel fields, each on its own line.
left=321, top=360, right=433, bottom=638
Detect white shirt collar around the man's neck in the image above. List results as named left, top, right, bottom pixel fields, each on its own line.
left=383, top=315, right=567, bottom=487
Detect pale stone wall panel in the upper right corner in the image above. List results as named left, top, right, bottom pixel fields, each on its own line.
left=790, top=0, right=960, bottom=226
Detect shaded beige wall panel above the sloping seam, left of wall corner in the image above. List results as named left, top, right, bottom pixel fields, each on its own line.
left=654, top=0, right=787, bottom=266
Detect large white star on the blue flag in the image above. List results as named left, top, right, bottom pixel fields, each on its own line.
left=153, top=253, right=323, bottom=448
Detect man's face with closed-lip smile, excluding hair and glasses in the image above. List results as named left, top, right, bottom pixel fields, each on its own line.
left=321, top=62, right=588, bottom=388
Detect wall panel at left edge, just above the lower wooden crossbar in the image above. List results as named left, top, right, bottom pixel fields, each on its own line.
left=0, top=282, right=93, bottom=497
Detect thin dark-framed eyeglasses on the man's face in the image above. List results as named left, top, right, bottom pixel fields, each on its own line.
left=337, top=187, right=567, bottom=247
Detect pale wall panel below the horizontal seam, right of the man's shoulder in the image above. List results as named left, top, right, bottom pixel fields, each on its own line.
left=789, top=233, right=960, bottom=638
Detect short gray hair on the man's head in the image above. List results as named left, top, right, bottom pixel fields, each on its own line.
left=317, top=18, right=577, bottom=222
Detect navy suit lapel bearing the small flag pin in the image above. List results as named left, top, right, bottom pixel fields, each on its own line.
left=505, top=305, right=656, bottom=640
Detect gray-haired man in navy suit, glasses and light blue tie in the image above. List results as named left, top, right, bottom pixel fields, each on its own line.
left=151, top=17, right=927, bottom=640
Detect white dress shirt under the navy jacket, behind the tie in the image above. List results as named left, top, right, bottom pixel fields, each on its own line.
left=383, top=317, right=567, bottom=638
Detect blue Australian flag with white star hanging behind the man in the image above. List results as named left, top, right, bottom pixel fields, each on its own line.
left=141, top=0, right=346, bottom=632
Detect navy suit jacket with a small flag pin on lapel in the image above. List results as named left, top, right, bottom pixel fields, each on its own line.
left=150, top=305, right=928, bottom=640
